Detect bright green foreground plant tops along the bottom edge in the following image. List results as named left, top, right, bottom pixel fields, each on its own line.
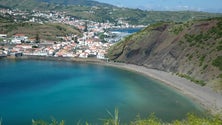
left=29, top=109, right=222, bottom=125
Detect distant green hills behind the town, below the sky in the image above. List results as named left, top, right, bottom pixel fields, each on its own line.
left=0, top=0, right=222, bottom=25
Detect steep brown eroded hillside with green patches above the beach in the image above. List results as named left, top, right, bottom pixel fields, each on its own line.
left=108, top=18, right=222, bottom=89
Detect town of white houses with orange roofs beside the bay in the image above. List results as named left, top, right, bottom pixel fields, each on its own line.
left=0, top=9, right=144, bottom=59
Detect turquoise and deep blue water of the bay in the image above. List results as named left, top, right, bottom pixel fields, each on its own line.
left=0, top=60, right=202, bottom=125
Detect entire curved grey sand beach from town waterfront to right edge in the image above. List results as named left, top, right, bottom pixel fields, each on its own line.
left=3, top=56, right=222, bottom=114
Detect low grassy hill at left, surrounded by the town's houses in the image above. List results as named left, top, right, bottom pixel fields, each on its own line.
left=0, top=23, right=80, bottom=40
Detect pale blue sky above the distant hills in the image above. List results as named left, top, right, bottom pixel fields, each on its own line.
left=96, top=0, right=222, bottom=13
